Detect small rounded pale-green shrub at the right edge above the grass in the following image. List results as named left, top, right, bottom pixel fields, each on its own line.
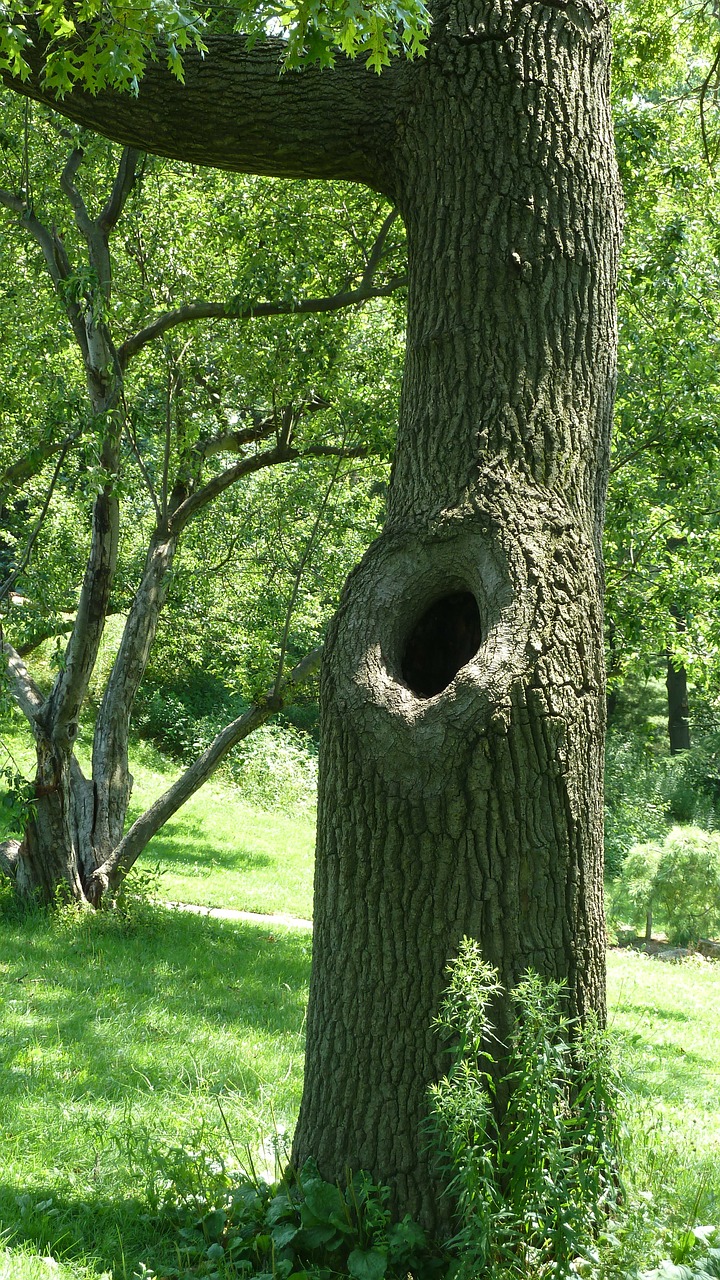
left=611, top=827, right=720, bottom=945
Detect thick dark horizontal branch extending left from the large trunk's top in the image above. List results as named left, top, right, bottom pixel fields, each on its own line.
left=4, top=34, right=399, bottom=195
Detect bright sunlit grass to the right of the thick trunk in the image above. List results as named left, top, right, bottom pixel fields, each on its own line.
left=609, top=950, right=720, bottom=1264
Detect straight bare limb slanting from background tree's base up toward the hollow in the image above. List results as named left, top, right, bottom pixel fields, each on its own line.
left=88, top=649, right=323, bottom=902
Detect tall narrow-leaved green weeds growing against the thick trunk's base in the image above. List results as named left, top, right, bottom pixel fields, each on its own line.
left=430, top=938, right=618, bottom=1280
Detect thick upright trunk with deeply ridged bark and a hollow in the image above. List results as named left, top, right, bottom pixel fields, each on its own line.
left=295, top=0, right=619, bottom=1224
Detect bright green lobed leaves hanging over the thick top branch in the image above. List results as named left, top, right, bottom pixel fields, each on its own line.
left=0, top=0, right=429, bottom=97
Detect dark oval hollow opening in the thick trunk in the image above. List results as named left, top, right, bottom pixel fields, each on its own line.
left=402, top=591, right=482, bottom=698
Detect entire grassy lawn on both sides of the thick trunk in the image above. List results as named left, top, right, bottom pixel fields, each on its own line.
left=0, top=721, right=720, bottom=1280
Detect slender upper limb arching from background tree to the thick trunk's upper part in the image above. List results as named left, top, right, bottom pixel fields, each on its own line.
left=118, top=275, right=407, bottom=369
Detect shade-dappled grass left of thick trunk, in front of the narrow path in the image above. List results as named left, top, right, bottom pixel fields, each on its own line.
left=0, top=909, right=310, bottom=1280
